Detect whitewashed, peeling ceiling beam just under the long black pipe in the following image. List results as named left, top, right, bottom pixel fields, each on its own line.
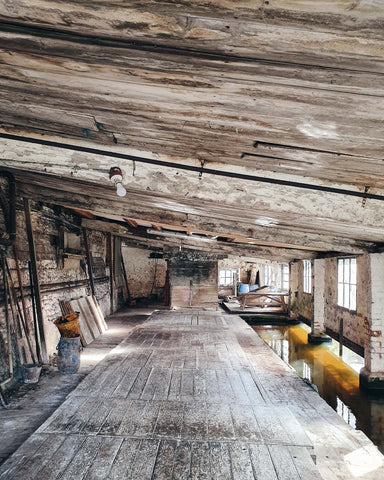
left=2, top=139, right=384, bottom=234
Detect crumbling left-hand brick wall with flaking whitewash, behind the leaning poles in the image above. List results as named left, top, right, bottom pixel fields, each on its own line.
left=0, top=202, right=110, bottom=380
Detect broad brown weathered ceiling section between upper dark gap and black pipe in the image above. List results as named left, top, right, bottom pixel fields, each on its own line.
left=0, top=38, right=384, bottom=165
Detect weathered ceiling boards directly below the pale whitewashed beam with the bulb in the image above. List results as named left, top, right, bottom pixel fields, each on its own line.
left=5, top=167, right=383, bottom=252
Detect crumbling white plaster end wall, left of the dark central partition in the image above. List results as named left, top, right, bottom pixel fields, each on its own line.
left=122, top=246, right=167, bottom=298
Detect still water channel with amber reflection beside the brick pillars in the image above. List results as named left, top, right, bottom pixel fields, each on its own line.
left=253, top=324, right=384, bottom=453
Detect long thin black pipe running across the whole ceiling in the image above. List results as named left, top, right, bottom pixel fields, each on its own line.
left=0, top=133, right=384, bottom=201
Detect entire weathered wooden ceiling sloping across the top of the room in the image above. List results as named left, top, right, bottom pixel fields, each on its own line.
left=0, top=0, right=384, bottom=260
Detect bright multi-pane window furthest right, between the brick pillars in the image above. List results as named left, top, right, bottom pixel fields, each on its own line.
left=337, top=258, right=356, bottom=310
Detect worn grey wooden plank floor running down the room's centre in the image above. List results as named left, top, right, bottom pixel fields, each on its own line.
left=0, top=311, right=384, bottom=480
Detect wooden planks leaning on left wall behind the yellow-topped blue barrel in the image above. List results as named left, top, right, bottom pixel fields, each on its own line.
left=60, top=295, right=108, bottom=347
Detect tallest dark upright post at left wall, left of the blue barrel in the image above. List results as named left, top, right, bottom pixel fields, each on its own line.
left=24, top=198, right=48, bottom=364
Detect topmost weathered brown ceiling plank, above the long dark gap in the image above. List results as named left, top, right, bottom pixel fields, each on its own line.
left=0, top=0, right=383, bottom=68
